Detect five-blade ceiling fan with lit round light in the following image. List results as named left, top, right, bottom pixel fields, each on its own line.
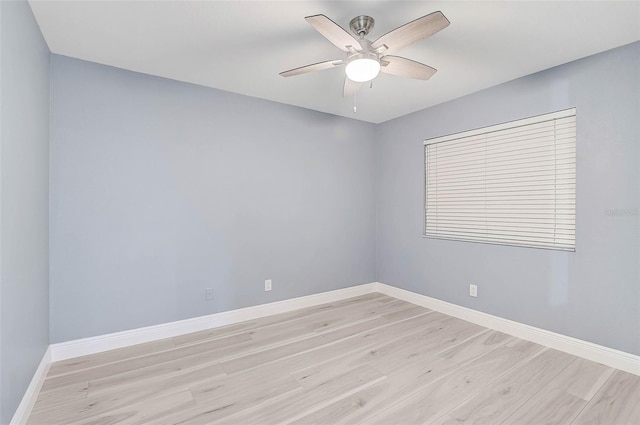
left=280, top=11, right=449, bottom=97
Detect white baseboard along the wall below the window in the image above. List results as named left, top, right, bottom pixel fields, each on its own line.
left=375, top=282, right=640, bottom=375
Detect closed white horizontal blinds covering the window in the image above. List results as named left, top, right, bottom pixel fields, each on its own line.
left=425, top=109, right=576, bottom=251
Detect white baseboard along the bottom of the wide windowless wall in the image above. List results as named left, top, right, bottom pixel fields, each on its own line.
left=50, top=283, right=376, bottom=362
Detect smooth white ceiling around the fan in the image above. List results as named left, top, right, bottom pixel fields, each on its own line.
left=30, top=0, right=640, bottom=123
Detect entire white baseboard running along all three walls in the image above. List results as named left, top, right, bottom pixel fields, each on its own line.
left=11, top=282, right=640, bottom=425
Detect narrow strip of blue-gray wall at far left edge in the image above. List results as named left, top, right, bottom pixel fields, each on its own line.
left=0, top=1, right=50, bottom=424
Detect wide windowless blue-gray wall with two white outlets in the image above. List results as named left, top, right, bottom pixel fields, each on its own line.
left=50, top=55, right=375, bottom=343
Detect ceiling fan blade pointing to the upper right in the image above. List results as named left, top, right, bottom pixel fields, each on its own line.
left=371, top=11, right=450, bottom=53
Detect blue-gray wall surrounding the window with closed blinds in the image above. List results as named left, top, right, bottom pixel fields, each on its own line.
left=376, top=42, right=640, bottom=354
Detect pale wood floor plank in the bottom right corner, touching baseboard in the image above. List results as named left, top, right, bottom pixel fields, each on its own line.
left=572, top=370, right=640, bottom=425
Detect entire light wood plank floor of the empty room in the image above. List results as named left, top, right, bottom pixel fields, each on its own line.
left=28, top=294, right=640, bottom=425
